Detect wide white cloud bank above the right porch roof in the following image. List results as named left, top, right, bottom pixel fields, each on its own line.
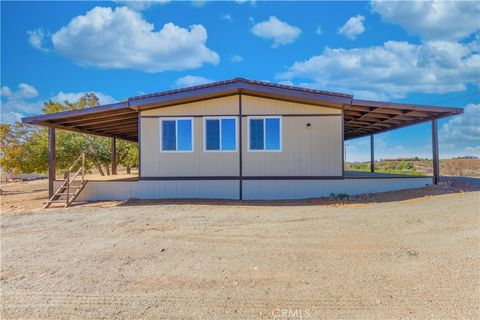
left=278, top=40, right=480, bottom=99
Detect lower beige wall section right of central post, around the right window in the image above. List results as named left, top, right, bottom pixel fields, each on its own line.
left=243, top=116, right=343, bottom=176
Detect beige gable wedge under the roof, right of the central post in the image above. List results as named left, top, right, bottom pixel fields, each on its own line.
left=242, top=95, right=342, bottom=115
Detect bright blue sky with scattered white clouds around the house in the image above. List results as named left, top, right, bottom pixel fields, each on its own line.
left=1, top=1, right=480, bottom=161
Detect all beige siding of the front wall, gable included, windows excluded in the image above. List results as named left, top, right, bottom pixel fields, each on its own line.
left=141, top=95, right=343, bottom=177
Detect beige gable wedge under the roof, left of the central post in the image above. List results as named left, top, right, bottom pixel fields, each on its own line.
left=141, top=95, right=238, bottom=116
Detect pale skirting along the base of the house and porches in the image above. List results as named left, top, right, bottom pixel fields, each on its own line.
left=55, top=177, right=432, bottom=201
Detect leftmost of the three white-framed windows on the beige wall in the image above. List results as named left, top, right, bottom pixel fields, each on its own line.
left=160, top=118, right=193, bottom=152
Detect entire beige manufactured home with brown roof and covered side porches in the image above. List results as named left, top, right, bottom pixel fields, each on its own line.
left=23, top=78, right=463, bottom=203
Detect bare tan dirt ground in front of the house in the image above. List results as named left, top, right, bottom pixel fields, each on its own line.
left=1, top=181, right=480, bottom=319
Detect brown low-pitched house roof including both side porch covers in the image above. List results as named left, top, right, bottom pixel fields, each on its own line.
left=22, top=78, right=463, bottom=141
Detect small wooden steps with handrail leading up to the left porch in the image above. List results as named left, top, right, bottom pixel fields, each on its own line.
left=43, top=153, right=88, bottom=209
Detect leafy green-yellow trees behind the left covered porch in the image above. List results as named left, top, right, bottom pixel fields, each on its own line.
left=0, top=93, right=138, bottom=175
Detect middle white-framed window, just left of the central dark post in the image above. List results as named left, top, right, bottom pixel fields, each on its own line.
left=204, top=118, right=237, bottom=151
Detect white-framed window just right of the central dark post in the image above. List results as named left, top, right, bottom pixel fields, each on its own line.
left=248, top=117, right=282, bottom=151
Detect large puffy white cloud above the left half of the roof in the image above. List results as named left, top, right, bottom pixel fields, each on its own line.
left=32, top=7, right=219, bottom=73
